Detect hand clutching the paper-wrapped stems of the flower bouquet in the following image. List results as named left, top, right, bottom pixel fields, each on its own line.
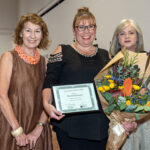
left=122, top=121, right=137, bottom=135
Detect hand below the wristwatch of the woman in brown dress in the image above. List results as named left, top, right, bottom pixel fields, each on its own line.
left=27, top=124, right=43, bottom=149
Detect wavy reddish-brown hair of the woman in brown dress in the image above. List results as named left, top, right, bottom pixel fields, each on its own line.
left=14, top=13, right=51, bottom=49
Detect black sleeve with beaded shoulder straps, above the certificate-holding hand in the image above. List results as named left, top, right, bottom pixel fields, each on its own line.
left=43, top=52, right=63, bottom=89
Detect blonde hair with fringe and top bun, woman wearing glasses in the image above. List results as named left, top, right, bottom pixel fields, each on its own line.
left=72, top=7, right=96, bottom=28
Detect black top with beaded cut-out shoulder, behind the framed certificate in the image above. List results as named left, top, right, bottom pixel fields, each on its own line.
left=44, top=45, right=109, bottom=140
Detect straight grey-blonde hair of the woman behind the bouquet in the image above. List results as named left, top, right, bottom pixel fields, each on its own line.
left=110, top=19, right=144, bottom=56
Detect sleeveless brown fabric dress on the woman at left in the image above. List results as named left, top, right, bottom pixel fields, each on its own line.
left=0, top=51, right=52, bottom=150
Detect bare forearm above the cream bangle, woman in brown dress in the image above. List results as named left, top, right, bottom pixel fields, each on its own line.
left=0, top=94, right=20, bottom=130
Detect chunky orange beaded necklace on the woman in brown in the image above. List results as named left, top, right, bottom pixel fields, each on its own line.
left=15, top=46, right=40, bottom=64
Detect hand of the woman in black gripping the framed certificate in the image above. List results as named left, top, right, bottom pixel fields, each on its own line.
left=44, top=103, right=65, bottom=120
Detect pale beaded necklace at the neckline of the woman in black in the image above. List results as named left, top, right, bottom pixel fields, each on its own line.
left=72, top=44, right=98, bottom=57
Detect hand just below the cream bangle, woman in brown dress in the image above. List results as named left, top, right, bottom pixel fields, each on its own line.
left=15, top=133, right=28, bottom=146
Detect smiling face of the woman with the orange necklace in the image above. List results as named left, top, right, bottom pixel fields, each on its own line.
left=20, top=22, right=42, bottom=49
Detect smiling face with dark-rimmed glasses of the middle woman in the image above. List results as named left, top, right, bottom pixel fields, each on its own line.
left=73, top=19, right=96, bottom=47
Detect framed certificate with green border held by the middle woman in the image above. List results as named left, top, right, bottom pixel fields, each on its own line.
left=52, top=83, right=99, bottom=114
